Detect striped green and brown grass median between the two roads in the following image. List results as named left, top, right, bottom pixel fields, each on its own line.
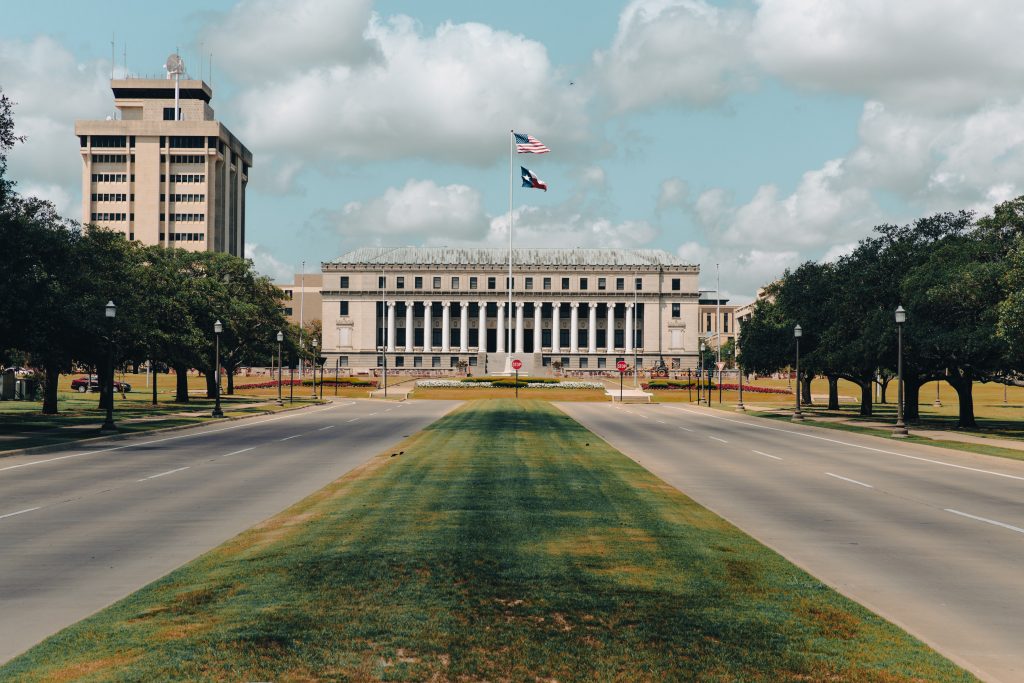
left=0, top=399, right=974, bottom=681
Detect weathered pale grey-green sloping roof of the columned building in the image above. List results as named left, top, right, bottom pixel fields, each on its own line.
left=325, top=247, right=691, bottom=267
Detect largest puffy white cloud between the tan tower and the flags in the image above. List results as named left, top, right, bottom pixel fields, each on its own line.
left=229, top=16, right=587, bottom=165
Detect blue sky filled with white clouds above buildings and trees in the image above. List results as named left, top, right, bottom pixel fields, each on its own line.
left=0, top=0, right=1024, bottom=303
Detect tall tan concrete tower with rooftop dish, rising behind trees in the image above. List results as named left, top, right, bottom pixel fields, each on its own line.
left=75, top=74, right=253, bottom=256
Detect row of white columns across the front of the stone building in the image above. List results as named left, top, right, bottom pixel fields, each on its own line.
left=387, top=301, right=633, bottom=353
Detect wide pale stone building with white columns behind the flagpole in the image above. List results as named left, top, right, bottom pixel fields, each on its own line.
left=322, top=247, right=699, bottom=374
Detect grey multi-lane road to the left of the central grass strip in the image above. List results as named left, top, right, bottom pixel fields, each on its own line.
left=0, top=399, right=458, bottom=661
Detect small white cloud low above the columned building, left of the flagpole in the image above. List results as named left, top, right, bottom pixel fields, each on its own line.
left=333, top=180, right=487, bottom=244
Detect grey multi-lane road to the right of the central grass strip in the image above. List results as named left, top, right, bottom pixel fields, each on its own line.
left=559, top=403, right=1024, bottom=683
